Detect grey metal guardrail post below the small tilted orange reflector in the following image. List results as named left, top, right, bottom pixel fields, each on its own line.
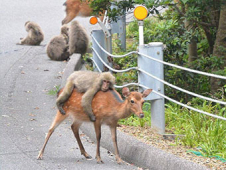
left=92, top=30, right=112, bottom=71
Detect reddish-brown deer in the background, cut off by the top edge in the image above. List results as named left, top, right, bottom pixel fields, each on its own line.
left=62, top=0, right=105, bottom=25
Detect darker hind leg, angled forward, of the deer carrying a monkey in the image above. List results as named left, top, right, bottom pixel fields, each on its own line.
left=71, top=122, right=92, bottom=159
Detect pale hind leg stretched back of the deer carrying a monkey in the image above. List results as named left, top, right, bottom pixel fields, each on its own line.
left=37, top=111, right=68, bottom=159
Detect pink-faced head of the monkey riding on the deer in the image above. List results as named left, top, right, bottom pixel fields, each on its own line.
left=100, top=72, right=115, bottom=92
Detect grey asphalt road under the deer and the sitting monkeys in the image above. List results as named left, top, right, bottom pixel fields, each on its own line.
left=0, top=0, right=137, bottom=170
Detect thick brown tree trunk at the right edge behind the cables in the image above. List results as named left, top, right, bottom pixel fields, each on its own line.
left=210, top=1, right=226, bottom=92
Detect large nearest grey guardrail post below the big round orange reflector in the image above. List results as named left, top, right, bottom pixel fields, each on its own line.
left=138, top=42, right=165, bottom=134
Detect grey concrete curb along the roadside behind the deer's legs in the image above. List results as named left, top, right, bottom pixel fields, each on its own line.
left=61, top=54, right=208, bottom=170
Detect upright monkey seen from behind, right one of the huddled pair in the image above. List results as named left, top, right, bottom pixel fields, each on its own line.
left=69, top=21, right=89, bottom=55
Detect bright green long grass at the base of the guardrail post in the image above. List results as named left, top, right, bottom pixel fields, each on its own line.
left=119, top=99, right=226, bottom=160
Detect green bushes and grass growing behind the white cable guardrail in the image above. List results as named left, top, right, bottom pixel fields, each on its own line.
left=113, top=9, right=226, bottom=159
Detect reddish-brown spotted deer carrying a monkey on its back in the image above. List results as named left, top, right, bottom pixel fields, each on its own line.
left=37, top=87, right=152, bottom=164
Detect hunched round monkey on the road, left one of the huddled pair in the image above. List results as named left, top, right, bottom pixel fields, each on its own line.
left=46, top=25, right=70, bottom=61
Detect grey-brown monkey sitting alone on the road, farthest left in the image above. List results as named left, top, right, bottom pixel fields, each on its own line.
left=17, top=21, right=44, bottom=45
